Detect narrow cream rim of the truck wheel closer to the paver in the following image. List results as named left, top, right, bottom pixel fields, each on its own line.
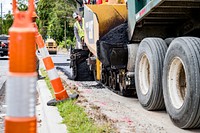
left=139, top=54, right=150, bottom=95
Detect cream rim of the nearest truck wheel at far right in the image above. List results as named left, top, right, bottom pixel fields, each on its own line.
left=168, top=57, right=187, bottom=109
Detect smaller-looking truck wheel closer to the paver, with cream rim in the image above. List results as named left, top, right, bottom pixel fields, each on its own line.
left=135, top=38, right=167, bottom=110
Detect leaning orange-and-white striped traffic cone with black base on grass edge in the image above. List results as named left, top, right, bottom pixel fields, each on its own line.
left=36, top=33, right=78, bottom=106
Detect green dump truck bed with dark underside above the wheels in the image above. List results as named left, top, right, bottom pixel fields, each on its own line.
left=129, top=0, right=200, bottom=41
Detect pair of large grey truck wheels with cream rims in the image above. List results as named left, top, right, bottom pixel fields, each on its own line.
left=135, top=37, right=200, bottom=128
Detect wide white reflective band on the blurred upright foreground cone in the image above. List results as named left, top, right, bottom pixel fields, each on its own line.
left=6, top=73, right=37, bottom=117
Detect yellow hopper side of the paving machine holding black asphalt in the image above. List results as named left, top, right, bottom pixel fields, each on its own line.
left=84, top=4, right=128, bottom=80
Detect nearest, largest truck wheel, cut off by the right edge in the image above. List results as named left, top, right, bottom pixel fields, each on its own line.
left=163, top=37, right=200, bottom=128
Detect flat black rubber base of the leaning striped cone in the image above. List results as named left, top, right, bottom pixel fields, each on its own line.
left=47, top=93, right=79, bottom=106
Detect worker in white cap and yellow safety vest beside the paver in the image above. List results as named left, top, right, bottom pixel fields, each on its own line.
left=73, top=12, right=84, bottom=49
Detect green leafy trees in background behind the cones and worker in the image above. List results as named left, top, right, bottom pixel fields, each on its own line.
left=0, top=0, right=76, bottom=44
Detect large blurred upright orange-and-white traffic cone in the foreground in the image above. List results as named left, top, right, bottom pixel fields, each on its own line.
left=5, top=0, right=37, bottom=133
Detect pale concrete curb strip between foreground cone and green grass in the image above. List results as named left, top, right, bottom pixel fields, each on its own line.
left=36, top=80, right=67, bottom=133
